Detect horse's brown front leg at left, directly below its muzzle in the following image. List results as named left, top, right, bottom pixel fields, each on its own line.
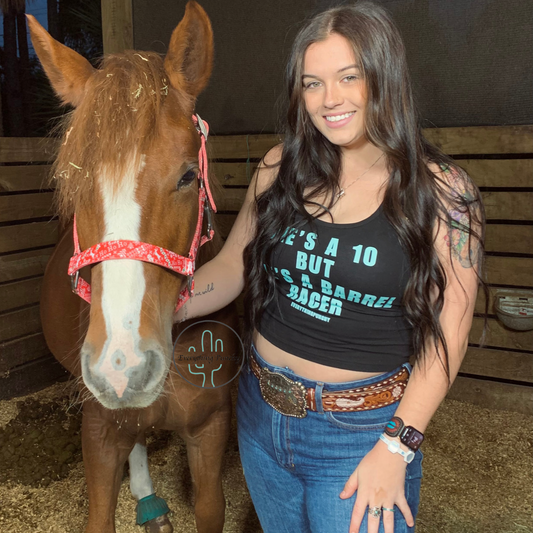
left=82, top=400, right=137, bottom=533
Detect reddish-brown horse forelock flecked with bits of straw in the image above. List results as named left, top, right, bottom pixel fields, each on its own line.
left=52, top=50, right=192, bottom=219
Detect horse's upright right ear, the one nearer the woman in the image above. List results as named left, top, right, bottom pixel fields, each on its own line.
left=165, top=0, right=214, bottom=98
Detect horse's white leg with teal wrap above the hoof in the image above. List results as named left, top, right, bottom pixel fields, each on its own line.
left=128, top=433, right=174, bottom=533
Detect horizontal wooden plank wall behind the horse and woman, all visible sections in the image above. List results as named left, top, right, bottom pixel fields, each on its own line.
left=0, top=126, right=533, bottom=414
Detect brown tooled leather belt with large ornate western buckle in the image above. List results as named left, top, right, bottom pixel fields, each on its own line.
left=250, top=354, right=409, bottom=418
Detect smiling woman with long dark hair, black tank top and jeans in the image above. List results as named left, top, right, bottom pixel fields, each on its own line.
left=177, top=2, right=483, bottom=533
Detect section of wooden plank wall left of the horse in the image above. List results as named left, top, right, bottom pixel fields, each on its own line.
left=0, top=137, right=65, bottom=399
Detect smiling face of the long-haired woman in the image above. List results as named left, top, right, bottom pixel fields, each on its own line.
left=302, top=33, right=367, bottom=148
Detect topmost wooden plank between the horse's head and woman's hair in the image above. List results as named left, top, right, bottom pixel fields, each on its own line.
left=208, top=134, right=281, bottom=159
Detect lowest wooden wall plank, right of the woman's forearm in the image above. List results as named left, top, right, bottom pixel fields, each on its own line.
left=447, top=376, right=533, bottom=415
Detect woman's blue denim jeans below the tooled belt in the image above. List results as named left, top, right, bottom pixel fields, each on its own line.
left=237, top=346, right=422, bottom=533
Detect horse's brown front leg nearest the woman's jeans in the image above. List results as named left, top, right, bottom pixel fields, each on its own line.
left=185, top=405, right=231, bottom=533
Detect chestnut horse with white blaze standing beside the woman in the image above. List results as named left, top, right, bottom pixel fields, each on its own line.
left=28, top=1, right=240, bottom=533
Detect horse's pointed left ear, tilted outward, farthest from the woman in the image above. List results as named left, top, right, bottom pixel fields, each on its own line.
left=26, top=15, right=95, bottom=106
